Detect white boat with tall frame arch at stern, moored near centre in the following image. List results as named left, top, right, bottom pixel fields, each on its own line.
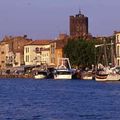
left=54, top=58, right=72, bottom=80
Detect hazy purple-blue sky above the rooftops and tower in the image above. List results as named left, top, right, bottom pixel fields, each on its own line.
left=0, top=0, right=120, bottom=40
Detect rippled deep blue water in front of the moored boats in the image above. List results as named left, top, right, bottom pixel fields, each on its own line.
left=0, top=79, right=120, bottom=120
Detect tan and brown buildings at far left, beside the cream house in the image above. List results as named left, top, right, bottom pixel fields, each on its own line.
left=0, top=36, right=32, bottom=69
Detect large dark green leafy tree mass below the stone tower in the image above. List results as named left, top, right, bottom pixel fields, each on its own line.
left=64, top=39, right=95, bottom=67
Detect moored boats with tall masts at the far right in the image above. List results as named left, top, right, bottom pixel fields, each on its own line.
left=95, top=41, right=120, bottom=81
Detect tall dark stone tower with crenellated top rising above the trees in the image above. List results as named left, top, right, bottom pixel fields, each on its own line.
left=70, top=11, right=88, bottom=37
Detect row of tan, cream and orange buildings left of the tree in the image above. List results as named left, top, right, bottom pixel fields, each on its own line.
left=0, top=34, right=67, bottom=70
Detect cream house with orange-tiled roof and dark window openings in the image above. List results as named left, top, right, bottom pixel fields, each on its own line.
left=24, top=40, right=51, bottom=65
